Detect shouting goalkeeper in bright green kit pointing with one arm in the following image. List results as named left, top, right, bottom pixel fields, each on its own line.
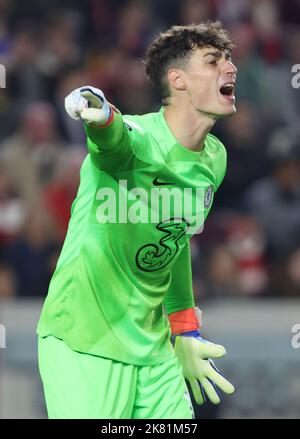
left=38, top=22, right=236, bottom=419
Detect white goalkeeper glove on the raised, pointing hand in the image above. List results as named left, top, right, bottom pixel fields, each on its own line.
left=65, top=86, right=112, bottom=126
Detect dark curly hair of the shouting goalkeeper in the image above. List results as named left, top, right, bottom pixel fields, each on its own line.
left=144, top=21, right=233, bottom=103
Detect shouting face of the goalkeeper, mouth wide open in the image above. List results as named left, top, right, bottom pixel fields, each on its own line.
left=184, top=47, right=237, bottom=118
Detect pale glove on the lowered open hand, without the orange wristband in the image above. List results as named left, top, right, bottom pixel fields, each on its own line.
left=174, top=331, right=235, bottom=404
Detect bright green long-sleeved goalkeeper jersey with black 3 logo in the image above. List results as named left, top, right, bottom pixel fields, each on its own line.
left=37, top=109, right=226, bottom=366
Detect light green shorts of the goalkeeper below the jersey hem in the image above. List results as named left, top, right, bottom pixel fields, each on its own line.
left=39, top=336, right=193, bottom=419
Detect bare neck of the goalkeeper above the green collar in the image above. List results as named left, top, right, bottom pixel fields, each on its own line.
left=164, top=104, right=216, bottom=151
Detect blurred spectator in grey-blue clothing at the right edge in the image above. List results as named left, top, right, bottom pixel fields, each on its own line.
left=246, top=131, right=300, bottom=260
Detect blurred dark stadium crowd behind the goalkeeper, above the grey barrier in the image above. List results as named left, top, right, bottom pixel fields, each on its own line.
left=0, top=0, right=300, bottom=301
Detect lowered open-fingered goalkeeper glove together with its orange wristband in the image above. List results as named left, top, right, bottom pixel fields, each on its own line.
left=169, top=308, right=235, bottom=404
